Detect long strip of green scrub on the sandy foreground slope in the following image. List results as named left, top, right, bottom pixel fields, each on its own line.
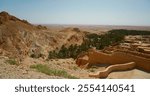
left=30, top=64, right=78, bottom=79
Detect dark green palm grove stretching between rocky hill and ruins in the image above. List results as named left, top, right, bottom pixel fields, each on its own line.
left=48, top=29, right=150, bottom=59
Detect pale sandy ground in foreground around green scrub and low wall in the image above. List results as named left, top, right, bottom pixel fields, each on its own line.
left=0, top=57, right=150, bottom=79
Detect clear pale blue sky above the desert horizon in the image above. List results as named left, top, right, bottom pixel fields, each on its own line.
left=0, top=0, right=150, bottom=26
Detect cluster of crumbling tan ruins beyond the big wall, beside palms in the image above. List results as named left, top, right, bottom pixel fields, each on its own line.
left=120, top=35, right=150, bottom=54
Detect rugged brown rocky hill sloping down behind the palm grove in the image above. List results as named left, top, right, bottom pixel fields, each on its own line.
left=0, top=12, right=84, bottom=58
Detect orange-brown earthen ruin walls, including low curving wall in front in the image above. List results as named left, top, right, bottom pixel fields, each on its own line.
left=76, top=49, right=150, bottom=78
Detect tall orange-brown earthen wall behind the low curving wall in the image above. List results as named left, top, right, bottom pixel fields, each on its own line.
left=76, top=50, right=150, bottom=72
